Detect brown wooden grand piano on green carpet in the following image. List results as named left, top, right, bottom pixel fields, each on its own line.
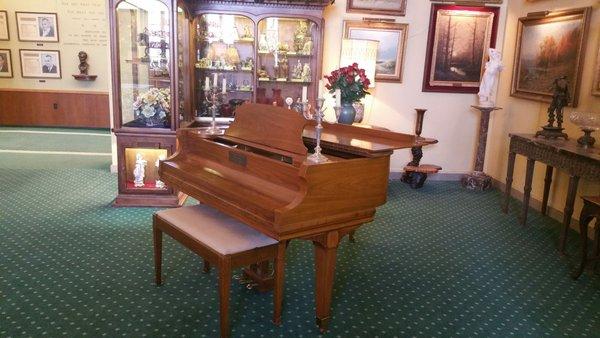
left=159, top=104, right=437, bottom=331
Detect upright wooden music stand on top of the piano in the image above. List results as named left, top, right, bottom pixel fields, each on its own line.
left=225, top=103, right=309, bottom=156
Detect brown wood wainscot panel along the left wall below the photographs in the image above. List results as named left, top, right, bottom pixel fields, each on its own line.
left=0, top=89, right=110, bottom=128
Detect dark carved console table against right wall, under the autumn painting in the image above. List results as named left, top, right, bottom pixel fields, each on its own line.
left=502, top=134, right=600, bottom=253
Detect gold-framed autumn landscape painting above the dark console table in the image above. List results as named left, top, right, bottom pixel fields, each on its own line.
left=511, top=7, right=591, bottom=107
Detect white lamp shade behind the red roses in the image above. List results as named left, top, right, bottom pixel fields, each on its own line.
left=340, top=39, right=379, bottom=88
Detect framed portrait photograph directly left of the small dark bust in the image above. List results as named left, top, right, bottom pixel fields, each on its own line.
left=19, top=49, right=61, bottom=79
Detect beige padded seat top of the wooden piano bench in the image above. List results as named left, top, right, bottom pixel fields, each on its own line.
left=156, top=205, right=278, bottom=255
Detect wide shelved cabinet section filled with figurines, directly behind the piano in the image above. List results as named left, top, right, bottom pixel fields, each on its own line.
left=187, top=0, right=331, bottom=121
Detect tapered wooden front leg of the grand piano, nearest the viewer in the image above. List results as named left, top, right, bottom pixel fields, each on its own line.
left=313, top=231, right=339, bottom=332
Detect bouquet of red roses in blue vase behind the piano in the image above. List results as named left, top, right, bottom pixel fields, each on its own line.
left=325, top=63, right=371, bottom=124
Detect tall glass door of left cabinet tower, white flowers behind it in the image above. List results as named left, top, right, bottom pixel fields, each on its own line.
left=117, top=0, right=171, bottom=128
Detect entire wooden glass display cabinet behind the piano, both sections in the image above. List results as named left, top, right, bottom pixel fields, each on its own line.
left=109, top=0, right=331, bottom=207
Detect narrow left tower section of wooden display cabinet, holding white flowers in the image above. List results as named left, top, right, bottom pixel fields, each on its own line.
left=109, top=0, right=192, bottom=206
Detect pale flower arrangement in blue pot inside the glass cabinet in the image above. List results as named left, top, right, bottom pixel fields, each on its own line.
left=133, top=88, right=171, bottom=127
